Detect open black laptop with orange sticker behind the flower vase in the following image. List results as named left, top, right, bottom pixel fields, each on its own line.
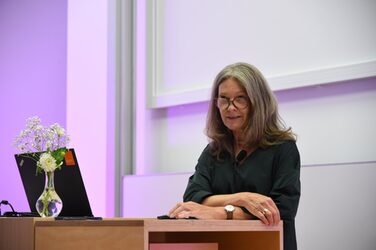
left=15, top=149, right=94, bottom=219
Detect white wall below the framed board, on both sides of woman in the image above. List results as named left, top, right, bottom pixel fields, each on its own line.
left=123, top=77, right=376, bottom=250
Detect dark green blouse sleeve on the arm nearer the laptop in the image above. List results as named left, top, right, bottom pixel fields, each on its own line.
left=183, top=147, right=213, bottom=203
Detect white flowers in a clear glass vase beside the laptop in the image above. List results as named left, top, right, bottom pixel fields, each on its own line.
left=14, top=116, right=69, bottom=217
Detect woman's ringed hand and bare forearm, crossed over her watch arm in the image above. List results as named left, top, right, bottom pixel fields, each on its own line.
left=227, top=192, right=281, bottom=225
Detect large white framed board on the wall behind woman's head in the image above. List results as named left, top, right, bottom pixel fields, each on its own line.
left=146, top=0, right=376, bottom=107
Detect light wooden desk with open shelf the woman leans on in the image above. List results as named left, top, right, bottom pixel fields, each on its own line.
left=0, top=218, right=283, bottom=250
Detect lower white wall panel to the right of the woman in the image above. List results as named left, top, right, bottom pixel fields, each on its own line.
left=296, top=162, right=376, bottom=250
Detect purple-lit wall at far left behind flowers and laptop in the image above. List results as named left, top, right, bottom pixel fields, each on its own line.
left=0, top=0, right=67, bottom=211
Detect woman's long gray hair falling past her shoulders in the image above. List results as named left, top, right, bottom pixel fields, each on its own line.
left=205, top=63, right=296, bottom=158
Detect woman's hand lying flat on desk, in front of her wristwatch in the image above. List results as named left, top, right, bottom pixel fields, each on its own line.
left=168, top=201, right=226, bottom=220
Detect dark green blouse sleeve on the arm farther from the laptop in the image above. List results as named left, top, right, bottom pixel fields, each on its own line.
left=270, top=141, right=300, bottom=220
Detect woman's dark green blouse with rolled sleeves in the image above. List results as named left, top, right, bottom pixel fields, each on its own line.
left=184, top=141, right=300, bottom=250
